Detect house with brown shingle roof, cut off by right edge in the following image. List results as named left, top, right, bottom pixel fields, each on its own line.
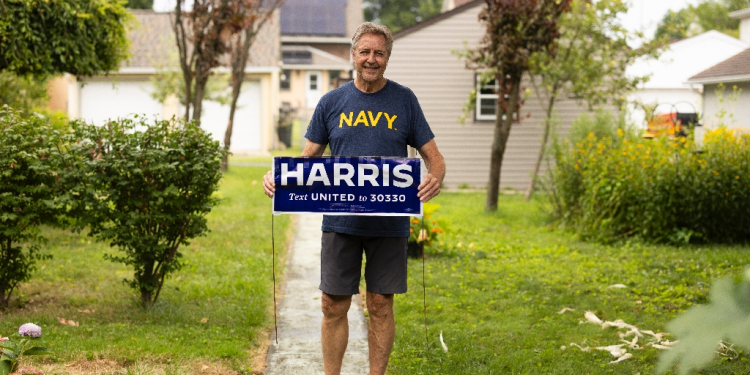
left=687, top=8, right=750, bottom=141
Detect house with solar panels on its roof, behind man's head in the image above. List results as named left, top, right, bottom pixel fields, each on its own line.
left=279, top=0, right=364, bottom=119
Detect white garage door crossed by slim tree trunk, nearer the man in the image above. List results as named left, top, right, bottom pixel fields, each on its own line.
left=201, top=81, right=262, bottom=154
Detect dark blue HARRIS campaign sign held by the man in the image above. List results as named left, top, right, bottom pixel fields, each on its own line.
left=273, top=157, right=422, bottom=216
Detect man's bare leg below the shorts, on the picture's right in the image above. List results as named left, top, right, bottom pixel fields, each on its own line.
left=367, top=292, right=396, bottom=375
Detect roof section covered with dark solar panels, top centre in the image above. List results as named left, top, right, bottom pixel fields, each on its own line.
left=281, top=0, right=347, bottom=36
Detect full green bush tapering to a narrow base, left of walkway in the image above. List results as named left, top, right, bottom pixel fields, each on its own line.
left=64, top=118, right=225, bottom=305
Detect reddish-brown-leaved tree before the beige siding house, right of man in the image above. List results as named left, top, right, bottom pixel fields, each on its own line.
left=464, top=0, right=571, bottom=211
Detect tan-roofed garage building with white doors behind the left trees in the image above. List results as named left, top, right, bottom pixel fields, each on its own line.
left=59, top=10, right=280, bottom=154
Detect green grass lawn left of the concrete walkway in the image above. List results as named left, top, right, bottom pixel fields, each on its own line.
left=0, top=167, right=289, bottom=374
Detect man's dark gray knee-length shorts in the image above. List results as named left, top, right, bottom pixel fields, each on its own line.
left=320, top=232, right=407, bottom=296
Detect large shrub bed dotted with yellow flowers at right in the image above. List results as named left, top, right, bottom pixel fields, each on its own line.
left=551, top=128, right=750, bottom=243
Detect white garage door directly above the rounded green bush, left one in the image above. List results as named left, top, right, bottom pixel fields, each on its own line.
left=81, top=78, right=162, bottom=125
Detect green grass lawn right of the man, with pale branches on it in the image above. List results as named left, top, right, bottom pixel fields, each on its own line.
left=388, top=193, right=750, bottom=375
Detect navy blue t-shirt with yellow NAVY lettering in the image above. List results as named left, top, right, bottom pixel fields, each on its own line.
left=305, top=80, right=435, bottom=237
